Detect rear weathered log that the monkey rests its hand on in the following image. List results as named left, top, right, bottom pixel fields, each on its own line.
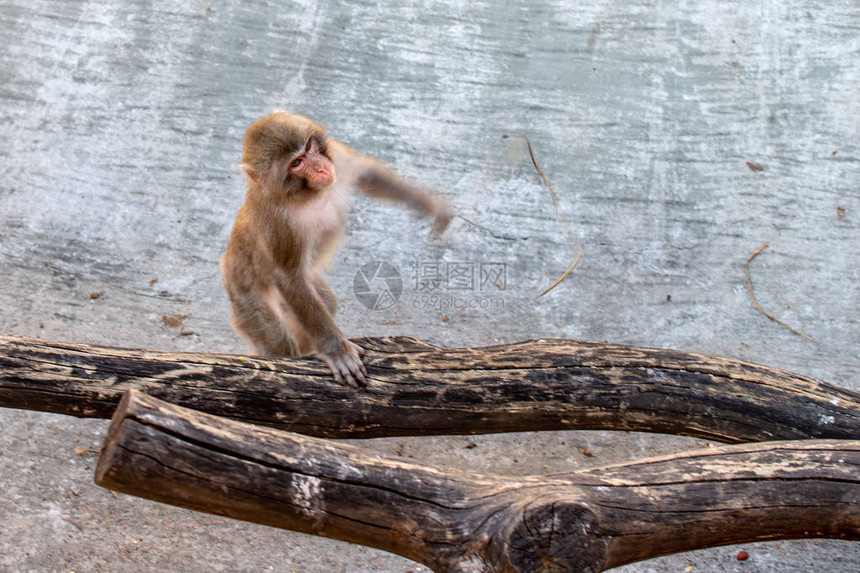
left=0, top=335, right=860, bottom=443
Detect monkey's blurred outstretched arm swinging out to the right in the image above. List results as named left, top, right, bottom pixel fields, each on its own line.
left=330, top=140, right=454, bottom=233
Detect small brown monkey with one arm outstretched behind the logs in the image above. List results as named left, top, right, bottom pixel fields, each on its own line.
left=220, top=110, right=453, bottom=388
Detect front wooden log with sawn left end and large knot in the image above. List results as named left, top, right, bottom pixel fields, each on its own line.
left=96, top=391, right=860, bottom=572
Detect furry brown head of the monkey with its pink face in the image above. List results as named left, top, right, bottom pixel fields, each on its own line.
left=243, top=112, right=335, bottom=200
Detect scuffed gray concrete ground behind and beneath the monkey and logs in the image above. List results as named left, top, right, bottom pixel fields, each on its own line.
left=0, top=0, right=860, bottom=573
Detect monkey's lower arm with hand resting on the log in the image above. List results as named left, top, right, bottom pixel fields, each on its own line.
left=275, top=270, right=367, bottom=388
